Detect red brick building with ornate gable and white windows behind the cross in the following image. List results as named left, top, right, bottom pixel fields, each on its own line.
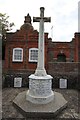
left=4, top=14, right=80, bottom=88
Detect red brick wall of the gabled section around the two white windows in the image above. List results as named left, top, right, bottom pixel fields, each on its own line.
left=4, top=30, right=48, bottom=70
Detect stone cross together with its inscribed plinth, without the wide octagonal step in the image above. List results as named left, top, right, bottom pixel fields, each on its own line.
left=26, top=7, right=54, bottom=104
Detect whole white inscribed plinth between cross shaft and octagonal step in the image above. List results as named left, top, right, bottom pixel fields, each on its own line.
left=26, top=74, right=54, bottom=104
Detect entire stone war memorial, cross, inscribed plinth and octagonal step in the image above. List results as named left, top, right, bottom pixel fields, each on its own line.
left=13, top=7, right=67, bottom=118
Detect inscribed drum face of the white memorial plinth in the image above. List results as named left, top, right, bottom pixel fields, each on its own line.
left=29, top=79, right=52, bottom=96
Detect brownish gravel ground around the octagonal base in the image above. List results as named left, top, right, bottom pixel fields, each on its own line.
left=2, top=88, right=80, bottom=120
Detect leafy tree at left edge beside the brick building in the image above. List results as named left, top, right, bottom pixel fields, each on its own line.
left=0, top=13, right=14, bottom=59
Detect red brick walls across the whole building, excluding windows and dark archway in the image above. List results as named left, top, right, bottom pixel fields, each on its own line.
left=4, top=16, right=80, bottom=70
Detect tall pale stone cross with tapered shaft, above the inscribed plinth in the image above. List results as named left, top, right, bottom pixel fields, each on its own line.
left=33, top=7, right=51, bottom=76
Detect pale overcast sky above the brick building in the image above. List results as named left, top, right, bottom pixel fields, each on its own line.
left=0, top=0, right=79, bottom=41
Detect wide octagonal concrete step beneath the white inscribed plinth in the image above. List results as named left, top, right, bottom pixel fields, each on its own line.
left=13, top=91, right=67, bottom=118
